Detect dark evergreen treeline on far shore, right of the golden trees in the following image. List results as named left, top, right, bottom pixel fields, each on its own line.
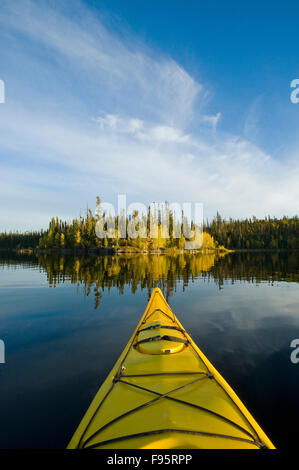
left=204, top=214, right=299, bottom=250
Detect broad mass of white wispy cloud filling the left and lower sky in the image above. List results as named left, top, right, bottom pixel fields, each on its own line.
left=0, top=0, right=299, bottom=229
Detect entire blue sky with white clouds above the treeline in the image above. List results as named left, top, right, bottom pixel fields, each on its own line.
left=0, top=0, right=299, bottom=230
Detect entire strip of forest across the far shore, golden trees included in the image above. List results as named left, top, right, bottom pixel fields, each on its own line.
left=0, top=202, right=299, bottom=252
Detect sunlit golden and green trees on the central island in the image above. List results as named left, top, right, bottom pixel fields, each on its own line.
left=38, top=198, right=219, bottom=251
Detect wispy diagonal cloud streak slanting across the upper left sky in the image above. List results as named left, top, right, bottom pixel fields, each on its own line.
left=0, top=0, right=201, bottom=124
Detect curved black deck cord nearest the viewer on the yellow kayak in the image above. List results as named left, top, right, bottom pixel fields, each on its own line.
left=82, top=429, right=264, bottom=449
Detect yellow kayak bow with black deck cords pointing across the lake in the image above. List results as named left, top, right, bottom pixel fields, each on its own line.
left=68, top=288, right=274, bottom=449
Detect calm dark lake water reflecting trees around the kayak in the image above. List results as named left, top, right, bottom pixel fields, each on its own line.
left=0, top=253, right=299, bottom=448
